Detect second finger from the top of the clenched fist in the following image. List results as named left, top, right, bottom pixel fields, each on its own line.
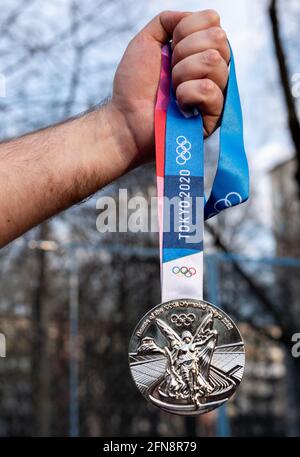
left=172, top=27, right=230, bottom=66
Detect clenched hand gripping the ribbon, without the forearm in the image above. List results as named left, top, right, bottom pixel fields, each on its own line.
left=111, top=10, right=230, bottom=166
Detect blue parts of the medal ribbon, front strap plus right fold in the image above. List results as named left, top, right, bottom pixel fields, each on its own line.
left=163, top=50, right=249, bottom=262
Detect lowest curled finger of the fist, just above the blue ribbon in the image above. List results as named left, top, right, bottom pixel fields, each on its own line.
left=176, top=79, right=224, bottom=135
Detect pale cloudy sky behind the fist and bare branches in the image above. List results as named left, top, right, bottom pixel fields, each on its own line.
left=0, top=0, right=300, bottom=255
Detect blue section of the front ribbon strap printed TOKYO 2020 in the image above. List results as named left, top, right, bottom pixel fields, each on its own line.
left=163, top=84, right=204, bottom=262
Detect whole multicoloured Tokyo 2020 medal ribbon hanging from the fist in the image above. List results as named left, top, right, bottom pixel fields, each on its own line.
left=155, top=45, right=249, bottom=302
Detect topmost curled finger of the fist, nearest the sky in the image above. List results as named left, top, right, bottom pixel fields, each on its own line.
left=172, top=10, right=220, bottom=48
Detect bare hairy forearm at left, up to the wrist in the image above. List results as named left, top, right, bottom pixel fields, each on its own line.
left=0, top=104, right=136, bottom=246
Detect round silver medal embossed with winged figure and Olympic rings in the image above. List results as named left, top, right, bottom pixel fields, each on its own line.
left=129, top=299, right=245, bottom=415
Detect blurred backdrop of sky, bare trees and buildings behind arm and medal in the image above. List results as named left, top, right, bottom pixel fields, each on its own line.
left=0, top=0, right=300, bottom=437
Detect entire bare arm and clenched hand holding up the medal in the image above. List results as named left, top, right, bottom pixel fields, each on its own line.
left=0, top=10, right=230, bottom=246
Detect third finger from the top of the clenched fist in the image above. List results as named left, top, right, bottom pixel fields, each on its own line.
left=172, top=49, right=228, bottom=90
